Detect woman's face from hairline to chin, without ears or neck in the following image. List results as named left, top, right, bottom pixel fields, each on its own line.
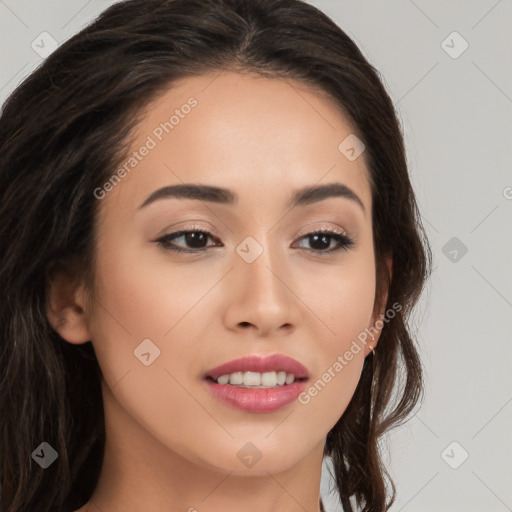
left=81, top=73, right=384, bottom=475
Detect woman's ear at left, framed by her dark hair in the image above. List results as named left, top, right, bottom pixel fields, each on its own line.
left=46, top=266, right=91, bottom=344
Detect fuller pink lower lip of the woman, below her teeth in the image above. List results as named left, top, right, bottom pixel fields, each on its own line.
left=205, top=379, right=307, bottom=413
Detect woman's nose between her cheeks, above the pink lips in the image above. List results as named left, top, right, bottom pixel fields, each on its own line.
left=225, top=244, right=301, bottom=338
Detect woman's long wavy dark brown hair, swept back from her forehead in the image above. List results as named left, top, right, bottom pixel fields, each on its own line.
left=0, top=0, right=431, bottom=512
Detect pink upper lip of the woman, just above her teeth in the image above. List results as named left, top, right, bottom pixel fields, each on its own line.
left=205, top=354, right=308, bottom=379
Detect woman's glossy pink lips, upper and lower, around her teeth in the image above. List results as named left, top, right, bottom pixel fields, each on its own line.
left=204, top=354, right=308, bottom=413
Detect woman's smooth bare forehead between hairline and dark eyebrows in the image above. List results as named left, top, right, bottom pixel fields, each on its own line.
left=102, top=72, right=371, bottom=214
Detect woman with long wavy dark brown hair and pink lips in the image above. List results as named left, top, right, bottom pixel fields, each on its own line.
left=0, top=0, right=430, bottom=512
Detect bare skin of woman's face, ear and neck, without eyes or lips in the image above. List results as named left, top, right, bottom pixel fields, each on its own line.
left=48, top=72, right=390, bottom=512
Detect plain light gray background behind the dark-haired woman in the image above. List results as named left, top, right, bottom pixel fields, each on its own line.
left=0, top=0, right=512, bottom=512
